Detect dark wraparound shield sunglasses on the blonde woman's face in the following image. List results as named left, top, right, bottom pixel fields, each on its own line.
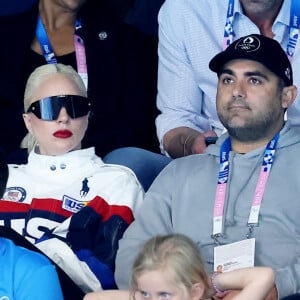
left=27, top=95, right=91, bottom=121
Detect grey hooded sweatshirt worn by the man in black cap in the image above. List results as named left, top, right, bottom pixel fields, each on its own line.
left=115, top=123, right=300, bottom=298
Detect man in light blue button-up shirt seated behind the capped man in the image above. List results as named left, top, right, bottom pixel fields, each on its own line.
left=156, top=0, right=300, bottom=158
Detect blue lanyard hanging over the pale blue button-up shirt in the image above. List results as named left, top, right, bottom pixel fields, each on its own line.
left=223, top=0, right=300, bottom=61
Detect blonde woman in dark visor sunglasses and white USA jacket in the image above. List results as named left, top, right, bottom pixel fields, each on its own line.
left=0, top=64, right=144, bottom=292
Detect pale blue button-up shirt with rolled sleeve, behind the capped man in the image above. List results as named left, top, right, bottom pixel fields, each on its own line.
left=156, top=0, right=300, bottom=149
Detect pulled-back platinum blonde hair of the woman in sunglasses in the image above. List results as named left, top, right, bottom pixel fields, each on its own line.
left=21, top=64, right=87, bottom=152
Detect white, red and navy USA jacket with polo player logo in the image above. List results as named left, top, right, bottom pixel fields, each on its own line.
left=0, top=148, right=144, bottom=292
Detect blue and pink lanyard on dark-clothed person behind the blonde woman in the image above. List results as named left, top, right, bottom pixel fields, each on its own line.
left=36, top=17, right=88, bottom=88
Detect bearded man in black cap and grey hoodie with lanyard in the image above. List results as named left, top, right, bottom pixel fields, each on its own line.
left=115, top=34, right=300, bottom=300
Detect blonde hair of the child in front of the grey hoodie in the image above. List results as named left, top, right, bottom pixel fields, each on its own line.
left=131, top=234, right=211, bottom=297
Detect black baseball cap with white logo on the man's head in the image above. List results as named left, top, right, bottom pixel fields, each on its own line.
left=209, top=34, right=293, bottom=86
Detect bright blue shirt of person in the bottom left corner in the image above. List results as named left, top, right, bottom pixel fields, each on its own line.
left=0, top=238, right=63, bottom=300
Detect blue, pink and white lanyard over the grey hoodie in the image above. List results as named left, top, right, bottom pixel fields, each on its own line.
left=212, top=133, right=279, bottom=243
